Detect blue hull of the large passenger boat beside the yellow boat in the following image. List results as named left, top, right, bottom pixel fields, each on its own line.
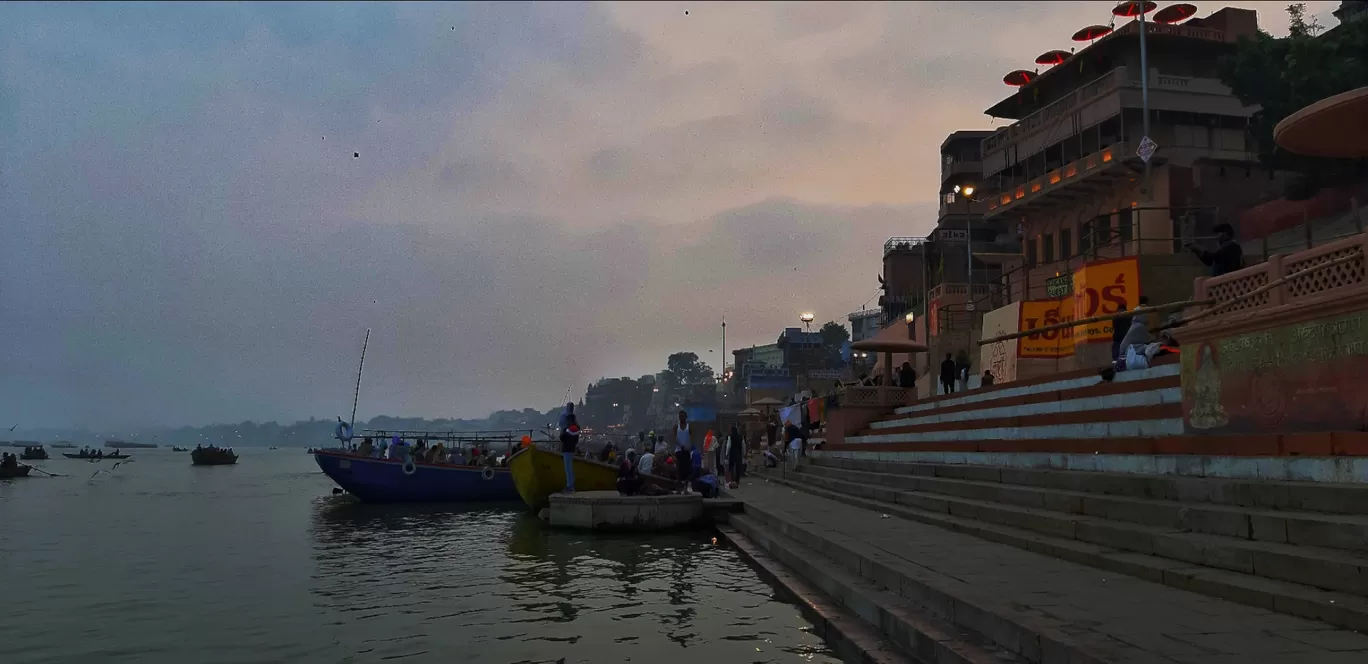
left=313, top=450, right=518, bottom=502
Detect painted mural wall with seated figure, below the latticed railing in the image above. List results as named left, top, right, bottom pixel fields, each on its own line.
left=1182, top=312, right=1368, bottom=434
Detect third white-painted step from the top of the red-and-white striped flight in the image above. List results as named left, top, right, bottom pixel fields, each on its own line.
left=847, top=403, right=1183, bottom=444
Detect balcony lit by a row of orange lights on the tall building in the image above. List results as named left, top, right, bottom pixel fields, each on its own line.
left=984, top=141, right=1142, bottom=219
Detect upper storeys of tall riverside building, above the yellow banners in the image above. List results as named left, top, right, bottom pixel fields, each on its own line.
left=975, top=8, right=1283, bottom=300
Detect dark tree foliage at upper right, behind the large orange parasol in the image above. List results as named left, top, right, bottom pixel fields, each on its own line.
left=1220, top=3, right=1368, bottom=179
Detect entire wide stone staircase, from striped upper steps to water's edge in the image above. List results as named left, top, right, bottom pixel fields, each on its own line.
left=731, top=355, right=1368, bottom=664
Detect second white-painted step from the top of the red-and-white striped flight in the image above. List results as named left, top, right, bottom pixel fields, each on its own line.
left=870, top=376, right=1183, bottom=431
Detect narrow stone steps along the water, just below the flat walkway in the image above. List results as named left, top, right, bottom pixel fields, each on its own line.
left=720, top=515, right=1026, bottom=664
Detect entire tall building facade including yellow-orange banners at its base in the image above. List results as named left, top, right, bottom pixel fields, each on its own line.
left=970, top=3, right=1286, bottom=378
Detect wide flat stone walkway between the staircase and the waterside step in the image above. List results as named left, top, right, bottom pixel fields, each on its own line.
left=740, top=482, right=1368, bottom=664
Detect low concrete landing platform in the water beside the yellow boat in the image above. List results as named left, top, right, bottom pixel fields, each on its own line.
left=549, top=491, right=703, bottom=531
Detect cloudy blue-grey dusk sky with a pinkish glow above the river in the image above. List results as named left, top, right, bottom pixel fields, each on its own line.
left=0, top=0, right=1338, bottom=427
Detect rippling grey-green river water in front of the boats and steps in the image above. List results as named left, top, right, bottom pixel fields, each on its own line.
left=0, top=449, right=839, bottom=664
